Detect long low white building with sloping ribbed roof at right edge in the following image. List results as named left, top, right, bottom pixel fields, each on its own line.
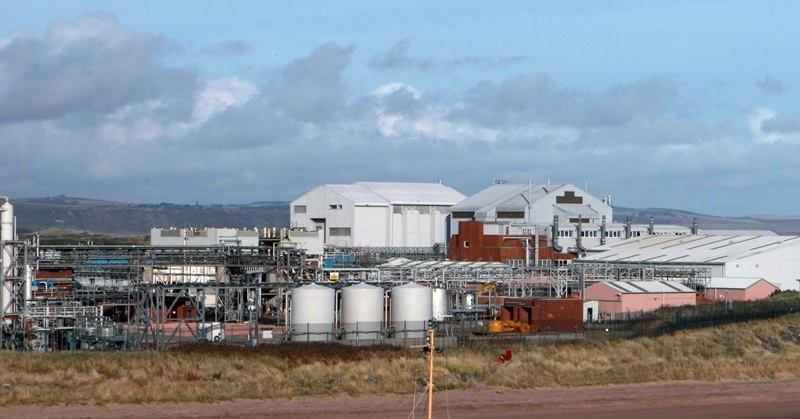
left=575, top=235, right=800, bottom=290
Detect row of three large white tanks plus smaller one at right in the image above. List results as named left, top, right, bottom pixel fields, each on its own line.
left=291, top=283, right=448, bottom=341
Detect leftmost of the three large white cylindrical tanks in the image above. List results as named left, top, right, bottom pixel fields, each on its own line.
left=291, top=284, right=336, bottom=342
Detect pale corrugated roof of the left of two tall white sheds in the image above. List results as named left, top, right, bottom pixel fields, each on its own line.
left=324, top=182, right=465, bottom=206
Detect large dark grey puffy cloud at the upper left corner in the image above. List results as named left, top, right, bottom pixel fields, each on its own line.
left=0, top=14, right=195, bottom=121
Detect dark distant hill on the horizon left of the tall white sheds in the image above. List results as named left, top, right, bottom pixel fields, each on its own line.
left=11, top=196, right=289, bottom=235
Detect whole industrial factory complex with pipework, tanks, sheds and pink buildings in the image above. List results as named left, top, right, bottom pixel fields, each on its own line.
left=0, top=181, right=800, bottom=351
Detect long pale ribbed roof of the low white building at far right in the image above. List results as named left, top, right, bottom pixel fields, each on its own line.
left=581, top=235, right=800, bottom=264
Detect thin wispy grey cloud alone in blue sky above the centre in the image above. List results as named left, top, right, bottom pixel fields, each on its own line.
left=369, top=39, right=528, bottom=71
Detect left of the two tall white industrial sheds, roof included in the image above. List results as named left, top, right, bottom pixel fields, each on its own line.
left=291, top=182, right=465, bottom=247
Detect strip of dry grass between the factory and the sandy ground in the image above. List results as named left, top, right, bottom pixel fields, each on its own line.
left=0, top=315, right=800, bottom=406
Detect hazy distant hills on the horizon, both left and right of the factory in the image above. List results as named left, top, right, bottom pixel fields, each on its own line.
left=6, top=196, right=800, bottom=236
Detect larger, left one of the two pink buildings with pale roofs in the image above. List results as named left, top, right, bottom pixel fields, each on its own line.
left=584, top=281, right=697, bottom=320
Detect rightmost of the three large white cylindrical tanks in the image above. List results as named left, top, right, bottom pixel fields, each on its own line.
left=391, top=283, right=433, bottom=338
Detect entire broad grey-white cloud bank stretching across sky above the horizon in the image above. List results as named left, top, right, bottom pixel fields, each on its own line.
left=0, top=14, right=800, bottom=217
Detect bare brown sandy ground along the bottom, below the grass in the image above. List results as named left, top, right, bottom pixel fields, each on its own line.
left=0, top=377, right=800, bottom=419
